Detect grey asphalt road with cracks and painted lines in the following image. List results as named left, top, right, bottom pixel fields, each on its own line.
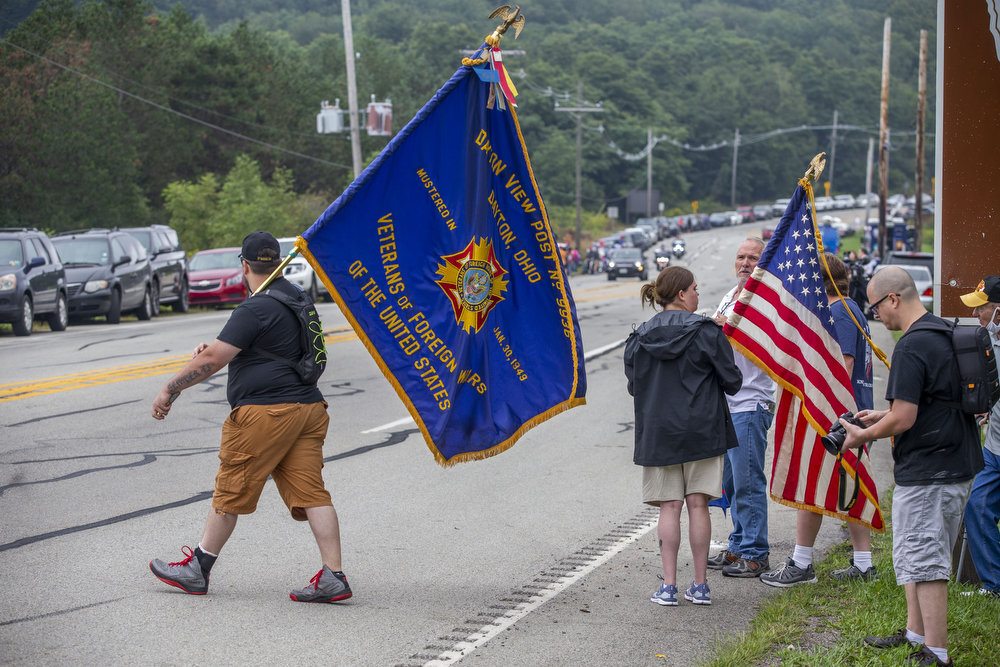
left=0, top=218, right=891, bottom=666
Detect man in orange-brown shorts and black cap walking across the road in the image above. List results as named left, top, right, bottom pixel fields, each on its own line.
left=149, top=232, right=352, bottom=602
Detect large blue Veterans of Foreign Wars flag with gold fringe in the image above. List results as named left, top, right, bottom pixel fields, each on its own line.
left=297, top=67, right=586, bottom=466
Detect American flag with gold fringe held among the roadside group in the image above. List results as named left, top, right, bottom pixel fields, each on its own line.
left=724, top=180, right=885, bottom=532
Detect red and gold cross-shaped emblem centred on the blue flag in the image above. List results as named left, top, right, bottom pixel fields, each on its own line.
left=437, top=237, right=508, bottom=334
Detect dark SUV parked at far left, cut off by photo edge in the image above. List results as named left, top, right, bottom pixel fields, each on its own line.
left=0, top=227, right=69, bottom=336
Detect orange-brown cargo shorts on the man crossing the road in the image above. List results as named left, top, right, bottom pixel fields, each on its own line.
left=212, top=402, right=333, bottom=521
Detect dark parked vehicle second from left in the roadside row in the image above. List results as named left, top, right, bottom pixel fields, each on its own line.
left=52, top=229, right=153, bottom=324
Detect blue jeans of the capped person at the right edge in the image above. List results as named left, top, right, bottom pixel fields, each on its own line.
left=965, top=449, right=1000, bottom=591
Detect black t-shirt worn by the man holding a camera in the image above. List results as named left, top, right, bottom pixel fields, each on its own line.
left=885, top=313, right=983, bottom=486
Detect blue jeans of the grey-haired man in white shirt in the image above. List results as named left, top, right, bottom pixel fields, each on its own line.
left=722, top=405, right=774, bottom=560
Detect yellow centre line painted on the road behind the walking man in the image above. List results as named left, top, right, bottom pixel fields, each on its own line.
left=0, top=326, right=358, bottom=403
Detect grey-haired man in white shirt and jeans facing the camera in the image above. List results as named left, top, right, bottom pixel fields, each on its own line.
left=708, top=237, right=776, bottom=577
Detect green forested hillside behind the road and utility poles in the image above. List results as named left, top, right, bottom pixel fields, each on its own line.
left=0, top=0, right=936, bottom=245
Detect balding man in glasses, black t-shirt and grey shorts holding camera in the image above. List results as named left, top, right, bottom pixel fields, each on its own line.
left=840, top=266, right=983, bottom=666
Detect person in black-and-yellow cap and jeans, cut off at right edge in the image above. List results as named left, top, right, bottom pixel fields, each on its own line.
left=962, top=276, right=1000, bottom=598
